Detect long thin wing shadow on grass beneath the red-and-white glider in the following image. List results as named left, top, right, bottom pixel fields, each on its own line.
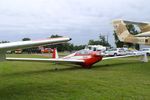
left=2, top=62, right=141, bottom=77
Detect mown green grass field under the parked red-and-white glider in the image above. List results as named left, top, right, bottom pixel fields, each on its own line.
left=0, top=54, right=150, bottom=100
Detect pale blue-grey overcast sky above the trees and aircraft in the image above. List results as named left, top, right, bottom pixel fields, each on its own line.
left=0, top=0, right=150, bottom=46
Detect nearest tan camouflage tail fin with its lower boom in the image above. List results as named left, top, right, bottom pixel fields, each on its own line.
left=113, top=20, right=146, bottom=44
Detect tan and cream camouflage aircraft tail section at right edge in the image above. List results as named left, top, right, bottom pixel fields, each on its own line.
left=113, top=20, right=150, bottom=45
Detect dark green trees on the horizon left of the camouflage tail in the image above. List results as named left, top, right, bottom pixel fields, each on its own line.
left=1, top=34, right=110, bottom=53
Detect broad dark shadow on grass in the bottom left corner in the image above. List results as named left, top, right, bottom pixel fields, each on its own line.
left=0, top=82, right=69, bottom=100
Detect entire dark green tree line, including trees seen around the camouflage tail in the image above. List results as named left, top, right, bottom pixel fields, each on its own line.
left=0, top=24, right=139, bottom=52
